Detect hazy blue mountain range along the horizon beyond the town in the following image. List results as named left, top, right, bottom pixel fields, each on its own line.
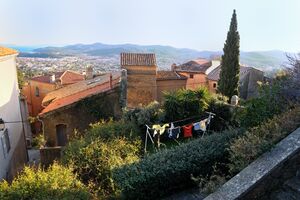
left=11, top=43, right=287, bottom=72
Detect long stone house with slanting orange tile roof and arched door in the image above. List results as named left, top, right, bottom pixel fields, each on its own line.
left=38, top=72, right=122, bottom=146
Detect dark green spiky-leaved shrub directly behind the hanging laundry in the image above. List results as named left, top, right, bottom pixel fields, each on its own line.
left=163, top=88, right=210, bottom=121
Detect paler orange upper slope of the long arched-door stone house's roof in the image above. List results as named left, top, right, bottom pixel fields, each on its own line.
left=42, top=72, right=120, bottom=106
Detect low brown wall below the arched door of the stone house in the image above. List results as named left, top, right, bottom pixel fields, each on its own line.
left=40, top=147, right=62, bottom=168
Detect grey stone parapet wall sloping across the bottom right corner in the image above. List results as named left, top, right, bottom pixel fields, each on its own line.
left=205, top=128, right=300, bottom=200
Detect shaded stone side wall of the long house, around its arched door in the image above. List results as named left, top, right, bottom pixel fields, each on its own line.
left=42, top=86, right=122, bottom=146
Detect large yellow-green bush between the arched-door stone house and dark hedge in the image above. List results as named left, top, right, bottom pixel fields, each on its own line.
left=63, top=121, right=141, bottom=197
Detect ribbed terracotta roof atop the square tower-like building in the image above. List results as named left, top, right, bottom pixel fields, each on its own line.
left=121, top=53, right=156, bottom=66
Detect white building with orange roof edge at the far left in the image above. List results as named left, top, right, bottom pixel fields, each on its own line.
left=0, top=47, right=28, bottom=180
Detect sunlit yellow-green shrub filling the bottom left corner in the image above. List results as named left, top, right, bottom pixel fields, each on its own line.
left=0, top=163, right=93, bottom=200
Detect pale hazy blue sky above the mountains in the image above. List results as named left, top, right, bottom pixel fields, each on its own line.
left=0, top=0, right=300, bottom=52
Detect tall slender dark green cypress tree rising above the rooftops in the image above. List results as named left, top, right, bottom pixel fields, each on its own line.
left=218, top=10, right=240, bottom=98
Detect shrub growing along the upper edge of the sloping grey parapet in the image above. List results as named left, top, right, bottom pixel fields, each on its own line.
left=229, top=107, right=300, bottom=174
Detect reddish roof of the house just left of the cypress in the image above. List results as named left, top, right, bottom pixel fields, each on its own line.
left=175, top=59, right=212, bottom=73
